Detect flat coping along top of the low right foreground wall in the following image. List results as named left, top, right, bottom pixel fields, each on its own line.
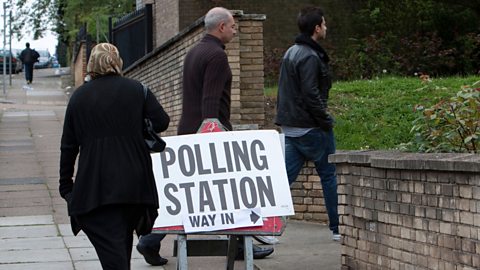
left=328, top=150, right=480, bottom=172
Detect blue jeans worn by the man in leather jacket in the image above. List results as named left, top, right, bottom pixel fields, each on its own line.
left=285, top=129, right=339, bottom=233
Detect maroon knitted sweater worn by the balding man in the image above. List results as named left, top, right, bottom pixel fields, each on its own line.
left=178, top=34, right=232, bottom=135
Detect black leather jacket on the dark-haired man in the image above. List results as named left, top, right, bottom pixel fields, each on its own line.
left=275, top=44, right=333, bottom=130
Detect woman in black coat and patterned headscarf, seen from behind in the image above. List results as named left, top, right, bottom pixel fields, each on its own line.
left=59, top=43, right=170, bottom=270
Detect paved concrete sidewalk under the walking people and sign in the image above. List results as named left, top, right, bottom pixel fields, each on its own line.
left=0, top=69, right=340, bottom=270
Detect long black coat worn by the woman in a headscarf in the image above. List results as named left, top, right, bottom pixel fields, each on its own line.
left=59, top=75, right=170, bottom=225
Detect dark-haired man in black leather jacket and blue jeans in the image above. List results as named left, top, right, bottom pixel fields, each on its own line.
left=275, top=7, right=340, bottom=240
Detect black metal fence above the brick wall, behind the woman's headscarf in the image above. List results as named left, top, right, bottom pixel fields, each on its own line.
left=109, top=4, right=153, bottom=69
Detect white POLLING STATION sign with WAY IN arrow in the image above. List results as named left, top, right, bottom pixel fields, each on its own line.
left=152, top=130, right=294, bottom=231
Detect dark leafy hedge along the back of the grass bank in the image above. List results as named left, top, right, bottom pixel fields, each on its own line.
left=331, top=32, right=480, bottom=80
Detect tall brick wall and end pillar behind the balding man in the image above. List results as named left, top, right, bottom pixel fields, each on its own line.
left=124, top=11, right=265, bottom=135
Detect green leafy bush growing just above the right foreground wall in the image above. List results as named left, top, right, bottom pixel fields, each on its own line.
left=412, top=81, right=480, bottom=153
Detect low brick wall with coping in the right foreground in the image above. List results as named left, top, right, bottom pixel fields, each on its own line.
left=330, top=152, right=480, bottom=270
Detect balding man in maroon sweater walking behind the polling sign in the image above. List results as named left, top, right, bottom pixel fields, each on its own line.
left=137, top=7, right=273, bottom=265
